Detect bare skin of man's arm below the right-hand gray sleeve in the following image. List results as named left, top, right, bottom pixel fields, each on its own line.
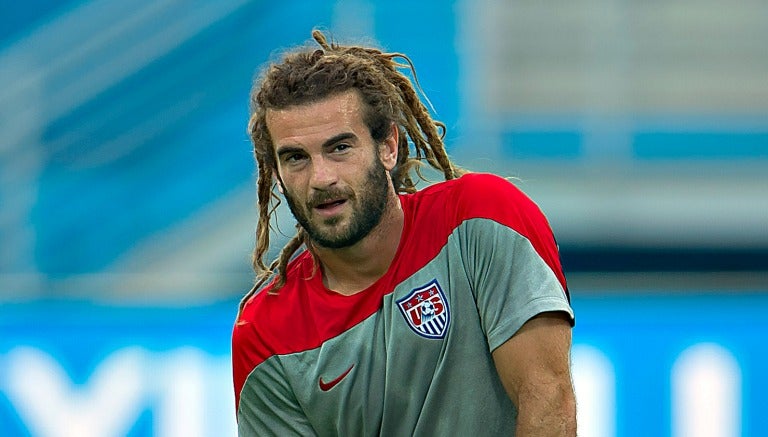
left=493, top=312, right=576, bottom=437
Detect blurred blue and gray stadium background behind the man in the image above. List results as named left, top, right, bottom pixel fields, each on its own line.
left=0, top=0, right=768, bottom=437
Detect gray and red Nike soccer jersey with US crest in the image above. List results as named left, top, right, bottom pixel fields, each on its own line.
left=232, top=173, right=573, bottom=436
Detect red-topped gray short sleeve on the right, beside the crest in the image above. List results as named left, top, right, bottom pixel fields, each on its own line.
left=458, top=176, right=574, bottom=350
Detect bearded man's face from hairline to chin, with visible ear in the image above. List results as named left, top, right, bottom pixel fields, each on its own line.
left=267, top=91, right=397, bottom=248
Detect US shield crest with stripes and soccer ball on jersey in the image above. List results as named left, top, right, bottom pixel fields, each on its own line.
left=397, top=279, right=451, bottom=338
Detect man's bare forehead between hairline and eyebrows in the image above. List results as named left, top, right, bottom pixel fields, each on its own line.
left=266, top=91, right=367, bottom=146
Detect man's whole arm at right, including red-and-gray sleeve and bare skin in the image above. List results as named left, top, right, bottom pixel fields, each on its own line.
left=450, top=175, right=576, bottom=437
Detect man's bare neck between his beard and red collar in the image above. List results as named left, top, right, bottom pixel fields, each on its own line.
left=313, top=192, right=404, bottom=295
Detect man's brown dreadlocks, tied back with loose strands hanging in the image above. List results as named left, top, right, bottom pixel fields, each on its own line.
left=246, top=30, right=464, bottom=298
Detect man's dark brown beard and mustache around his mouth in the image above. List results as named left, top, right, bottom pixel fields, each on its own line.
left=283, top=157, right=389, bottom=249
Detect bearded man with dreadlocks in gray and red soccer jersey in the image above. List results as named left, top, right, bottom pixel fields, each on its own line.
left=232, top=31, right=576, bottom=436
